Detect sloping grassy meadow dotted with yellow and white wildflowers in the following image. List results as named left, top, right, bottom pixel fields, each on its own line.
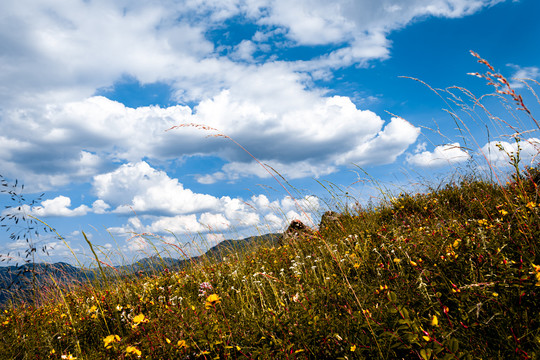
left=0, top=52, right=540, bottom=360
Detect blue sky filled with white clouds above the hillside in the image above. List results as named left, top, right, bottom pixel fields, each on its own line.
left=0, top=0, right=540, bottom=265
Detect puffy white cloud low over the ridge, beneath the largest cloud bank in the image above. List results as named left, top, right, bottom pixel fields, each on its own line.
left=94, top=162, right=320, bottom=236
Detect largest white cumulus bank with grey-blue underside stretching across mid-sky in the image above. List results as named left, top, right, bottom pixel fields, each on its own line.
left=0, top=86, right=419, bottom=188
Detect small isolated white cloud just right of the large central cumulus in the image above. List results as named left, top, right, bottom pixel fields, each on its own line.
left=407, top=143, right=471, bottom=168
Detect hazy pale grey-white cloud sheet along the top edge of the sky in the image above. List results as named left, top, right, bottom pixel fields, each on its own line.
left=0, top=0, right=504, bottom=107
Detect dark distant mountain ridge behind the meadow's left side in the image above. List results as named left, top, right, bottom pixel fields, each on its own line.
left=0, top=233, right=281, bottom=306
